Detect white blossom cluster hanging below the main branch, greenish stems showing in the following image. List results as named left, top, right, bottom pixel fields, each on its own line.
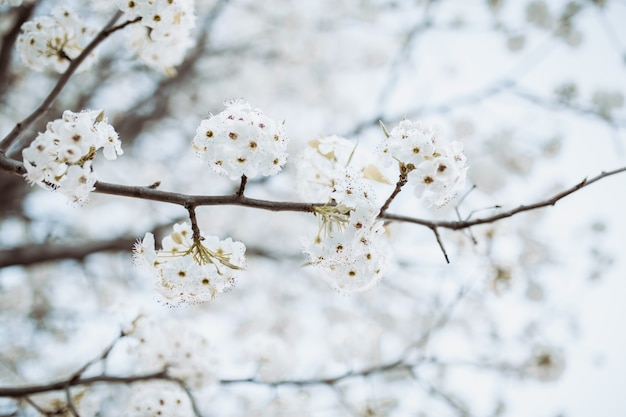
left=134, top=223, right=246, bottom=305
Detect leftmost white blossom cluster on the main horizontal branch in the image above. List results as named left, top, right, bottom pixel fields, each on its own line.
left=22, top=110, right=123, bottom=203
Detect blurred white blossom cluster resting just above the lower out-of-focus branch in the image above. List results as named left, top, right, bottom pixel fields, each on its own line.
left=128, top=317, right=217, bottom=388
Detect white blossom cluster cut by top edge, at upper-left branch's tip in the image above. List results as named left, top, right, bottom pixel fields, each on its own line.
left=119, top=0, right=196, bottom=75
